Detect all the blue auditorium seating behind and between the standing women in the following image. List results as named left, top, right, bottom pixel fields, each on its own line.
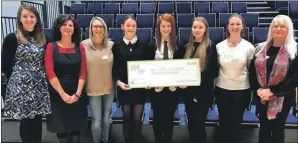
left=1, top=1, right=298, bottom=125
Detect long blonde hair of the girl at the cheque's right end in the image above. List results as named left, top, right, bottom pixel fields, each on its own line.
left=184, top=17, right=211, bottom=71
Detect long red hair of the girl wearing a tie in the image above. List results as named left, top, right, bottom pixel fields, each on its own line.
left=155, top=13, right=177, bottom=51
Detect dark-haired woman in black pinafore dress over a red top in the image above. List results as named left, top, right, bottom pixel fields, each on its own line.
left=45, top=16, right=87, bottom=143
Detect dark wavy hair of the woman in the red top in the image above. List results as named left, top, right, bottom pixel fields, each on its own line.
left=53, top=15, right=81, bottom=44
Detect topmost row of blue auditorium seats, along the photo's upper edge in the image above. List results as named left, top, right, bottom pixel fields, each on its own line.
left=71, top=2, right=247, bottom=15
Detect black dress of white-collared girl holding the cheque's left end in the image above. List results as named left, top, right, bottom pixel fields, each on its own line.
left=112, top=40, right=147, bottom=105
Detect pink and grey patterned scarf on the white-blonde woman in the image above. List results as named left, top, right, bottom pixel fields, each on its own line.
left=255, top=46, right=289, bottom=120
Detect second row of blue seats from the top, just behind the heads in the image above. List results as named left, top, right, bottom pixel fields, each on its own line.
left=63, top=13, right=259, bottom=28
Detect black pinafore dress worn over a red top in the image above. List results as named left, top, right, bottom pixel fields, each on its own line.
left=47, top=42, right=87, bottom=133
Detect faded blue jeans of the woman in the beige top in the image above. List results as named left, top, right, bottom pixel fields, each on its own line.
left=89, top=93, right=114, bottom=143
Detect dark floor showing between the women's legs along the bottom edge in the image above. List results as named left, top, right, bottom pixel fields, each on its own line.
left=1, top=121, right=298, bottom=143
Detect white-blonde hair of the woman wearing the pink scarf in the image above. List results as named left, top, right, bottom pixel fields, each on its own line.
left=256, top=15, right=297, bottom=59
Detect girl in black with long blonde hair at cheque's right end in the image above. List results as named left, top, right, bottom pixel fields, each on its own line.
left=180, top=17, right=218, bottom=143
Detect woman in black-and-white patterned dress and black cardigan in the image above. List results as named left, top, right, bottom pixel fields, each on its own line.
left=2, top=4, right=51, bottom=143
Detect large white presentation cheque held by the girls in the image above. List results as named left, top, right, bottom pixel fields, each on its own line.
left=127, top=59, right=201, bottom=88
